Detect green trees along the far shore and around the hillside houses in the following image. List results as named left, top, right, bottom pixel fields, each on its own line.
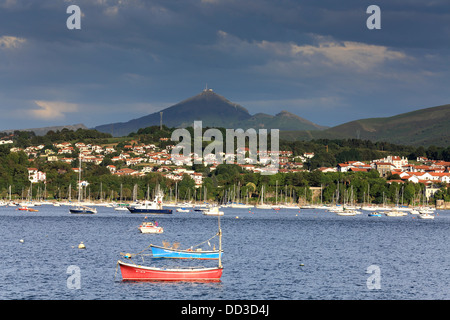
left=0, top=126, right=450, bottom=204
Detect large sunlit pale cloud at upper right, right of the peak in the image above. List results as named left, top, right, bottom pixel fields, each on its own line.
left=216, top=30, right=411, bottom=74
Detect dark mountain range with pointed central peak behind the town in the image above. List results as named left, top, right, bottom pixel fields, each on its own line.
left=2, top=89, right=450, bottom=147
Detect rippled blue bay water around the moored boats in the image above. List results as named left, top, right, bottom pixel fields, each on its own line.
left=0, top=205, right=450, bottom=300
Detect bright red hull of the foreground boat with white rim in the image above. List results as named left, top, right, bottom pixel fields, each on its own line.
left=118, top=260, right=223, bottom=281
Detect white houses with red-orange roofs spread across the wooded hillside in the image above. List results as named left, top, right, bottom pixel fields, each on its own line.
left=0, top=138, right=450, bottom=197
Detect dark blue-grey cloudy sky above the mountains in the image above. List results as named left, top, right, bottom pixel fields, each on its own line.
left=0, top=0, right=450, bottom=131
